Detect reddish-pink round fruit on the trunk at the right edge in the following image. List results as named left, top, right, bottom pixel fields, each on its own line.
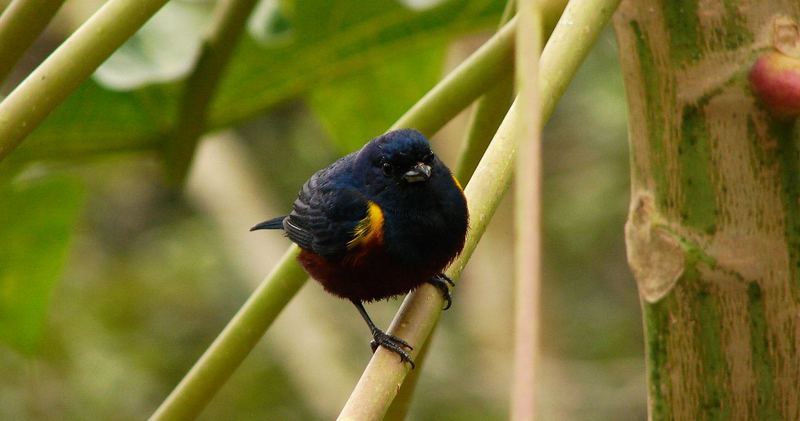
left=749, top=51, right=800, bottom=118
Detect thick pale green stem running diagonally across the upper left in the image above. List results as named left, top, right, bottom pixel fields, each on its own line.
left=0, top=0, right=167, bottom=161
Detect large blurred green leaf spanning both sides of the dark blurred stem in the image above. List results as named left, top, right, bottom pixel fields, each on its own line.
left=17, top=0, right=503, bottom=159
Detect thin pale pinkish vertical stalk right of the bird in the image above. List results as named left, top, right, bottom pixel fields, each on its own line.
left=511, top=1, right=542, bottom=421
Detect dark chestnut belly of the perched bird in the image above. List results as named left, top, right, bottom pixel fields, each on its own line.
left=297, top=250, right=440, bottom=301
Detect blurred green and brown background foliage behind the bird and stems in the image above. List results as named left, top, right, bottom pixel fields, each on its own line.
left=0, top=0, right=646, bottom=420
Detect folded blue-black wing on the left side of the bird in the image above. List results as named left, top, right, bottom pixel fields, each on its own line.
left=283, top=169, right=374, bottom=258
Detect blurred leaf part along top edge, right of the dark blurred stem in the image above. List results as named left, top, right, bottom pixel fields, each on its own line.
left=210, top=0, right=503, bottom=127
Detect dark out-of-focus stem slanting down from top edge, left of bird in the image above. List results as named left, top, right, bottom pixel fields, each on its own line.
left=166, top=0, right=258, bottom=184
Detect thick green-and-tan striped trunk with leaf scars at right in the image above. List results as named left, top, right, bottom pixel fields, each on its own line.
left=614, top=0, right=800, bottom=420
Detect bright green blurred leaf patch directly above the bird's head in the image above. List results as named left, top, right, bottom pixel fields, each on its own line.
left=309, top=42, right=444, bottom=154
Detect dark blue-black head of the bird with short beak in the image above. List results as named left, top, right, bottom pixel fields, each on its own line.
left=356, top=129, right=443, bottom=192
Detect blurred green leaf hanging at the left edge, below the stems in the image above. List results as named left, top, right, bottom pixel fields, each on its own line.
left=0, top=177, right=84, bottom=354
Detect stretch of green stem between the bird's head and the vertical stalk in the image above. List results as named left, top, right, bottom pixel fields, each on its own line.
left=390, top=19, right=517, bottom=136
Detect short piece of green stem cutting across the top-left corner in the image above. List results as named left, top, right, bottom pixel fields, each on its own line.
left=0, top=0, right=64, bottom=86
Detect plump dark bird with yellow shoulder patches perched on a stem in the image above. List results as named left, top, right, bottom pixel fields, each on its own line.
left=250, top=129, right=469, bottom=367
